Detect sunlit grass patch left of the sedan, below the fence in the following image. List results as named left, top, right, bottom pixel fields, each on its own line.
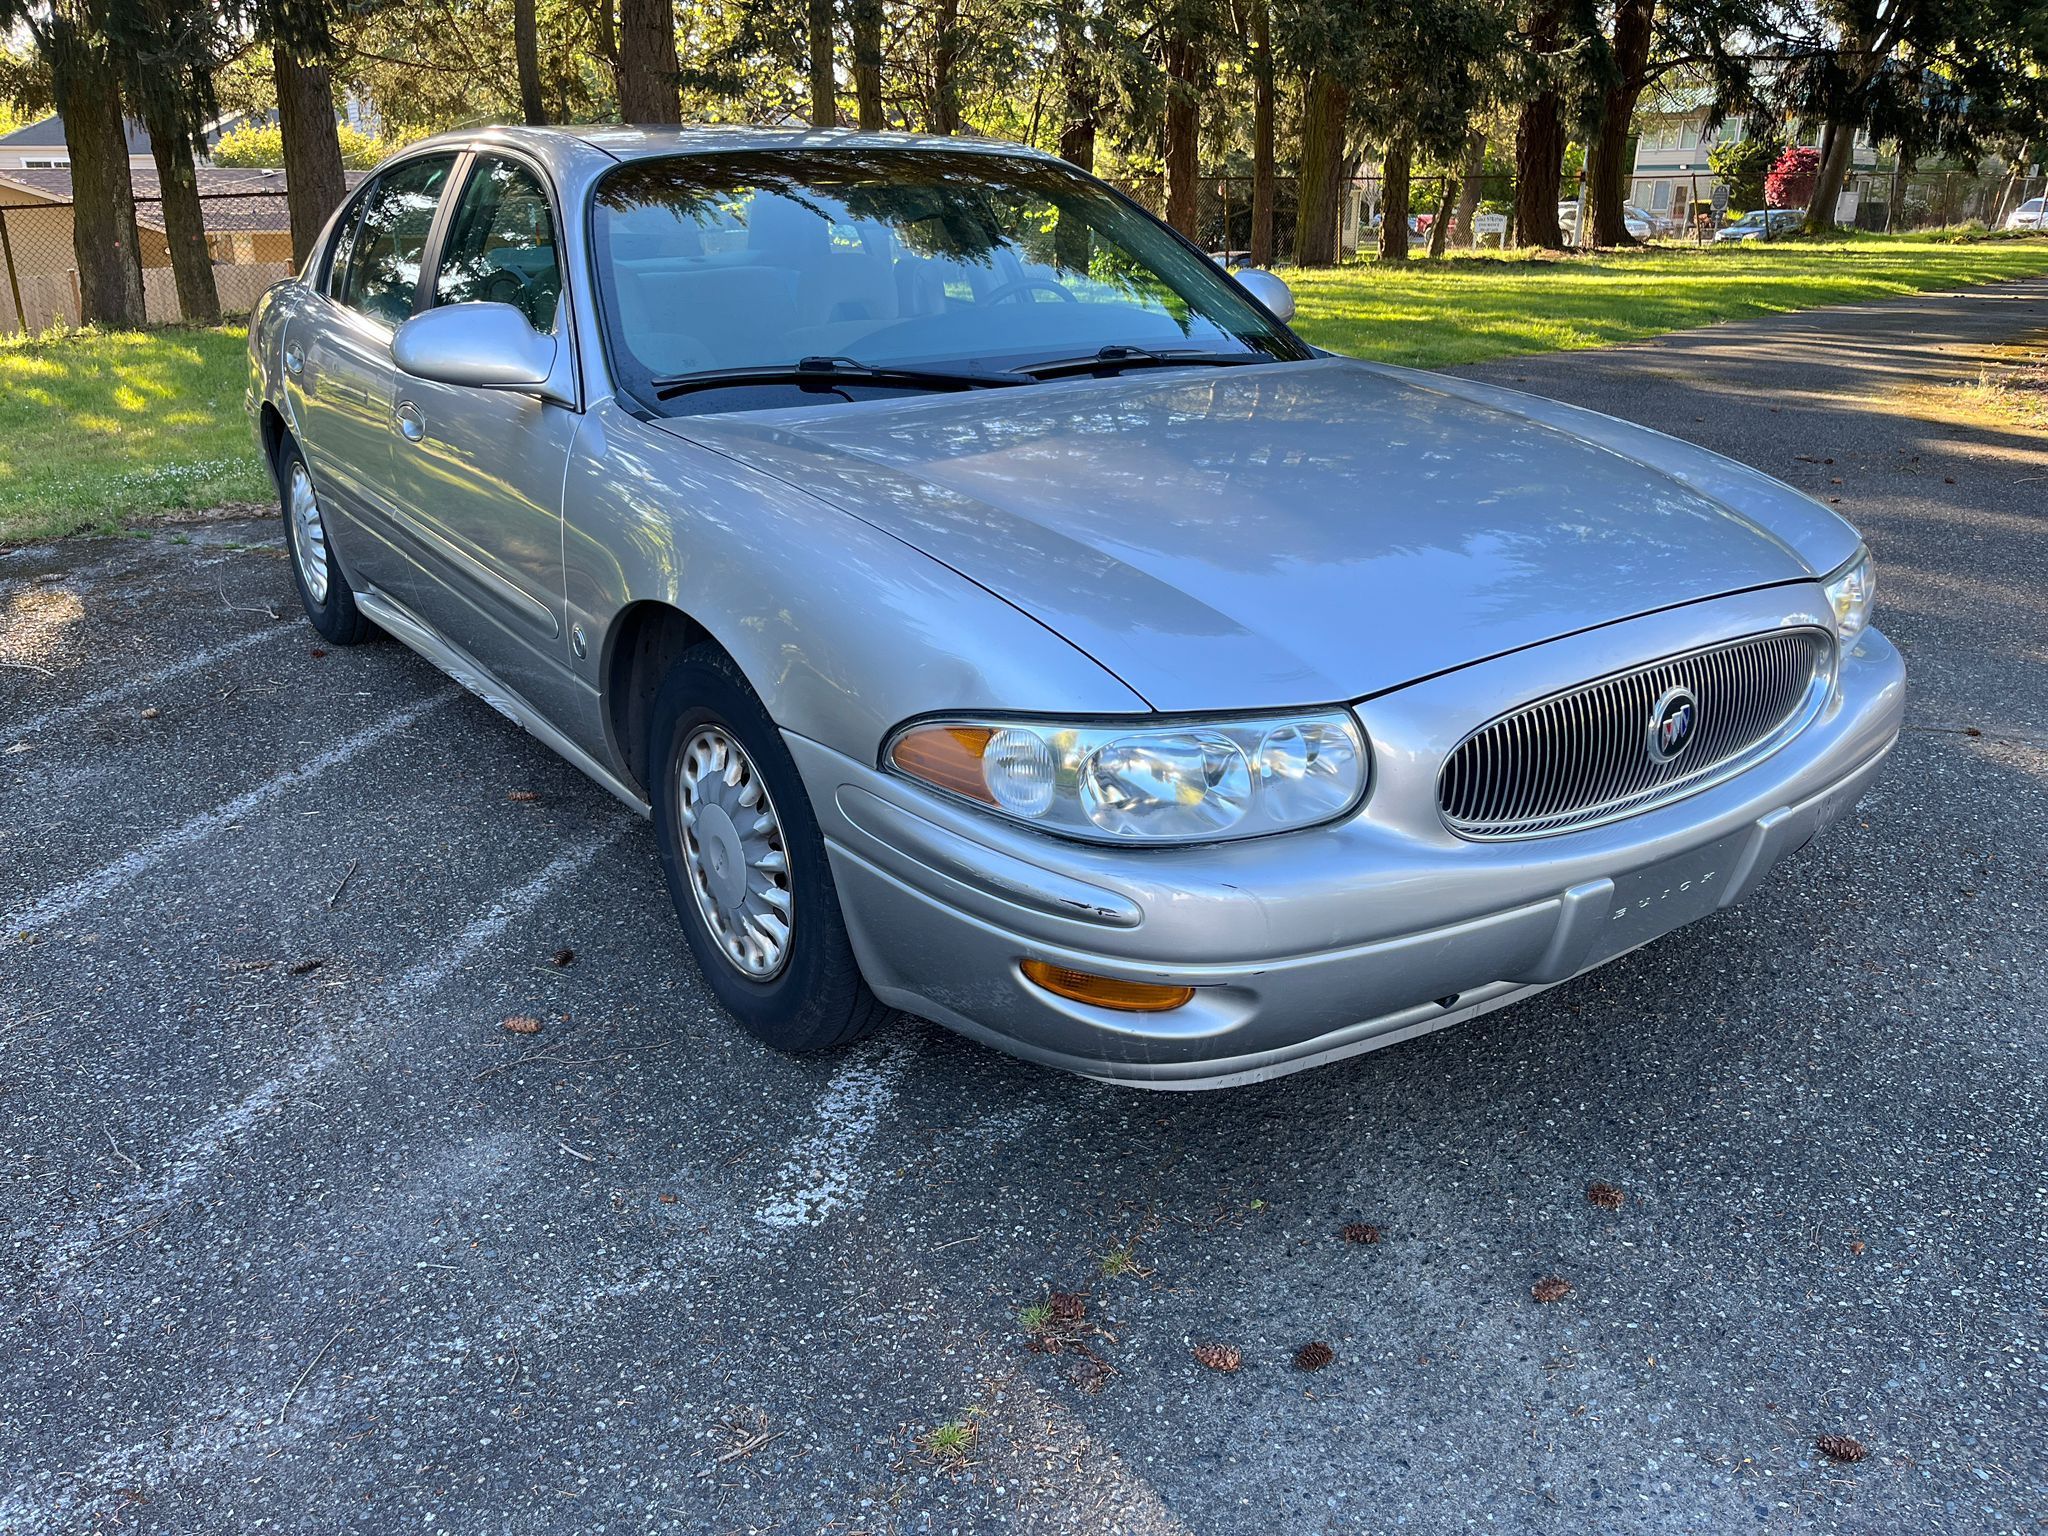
left=0, top=326, right=272, bottom=547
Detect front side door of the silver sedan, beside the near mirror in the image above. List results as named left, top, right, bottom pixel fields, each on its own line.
left=391, top=152, right=582, bottom=719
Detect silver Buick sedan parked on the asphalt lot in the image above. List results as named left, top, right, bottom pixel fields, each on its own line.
left=248, top=129, right=1905, bottom=1087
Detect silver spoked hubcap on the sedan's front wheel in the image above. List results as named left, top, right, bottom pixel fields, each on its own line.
left=676, top=725, right=793, bottom=981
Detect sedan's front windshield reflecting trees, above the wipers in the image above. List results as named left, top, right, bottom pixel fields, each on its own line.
left=592, top=147, right=1313, bottom=412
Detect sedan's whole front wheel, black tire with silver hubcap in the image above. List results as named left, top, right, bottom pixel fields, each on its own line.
left=647, top=645, right=887, bottom=1053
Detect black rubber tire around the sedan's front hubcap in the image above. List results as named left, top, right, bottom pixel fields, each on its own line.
left=647, top=645, right=889, bottom=1055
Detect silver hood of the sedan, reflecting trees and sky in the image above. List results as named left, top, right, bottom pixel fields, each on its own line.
left=664, top=358, right=1855, bottom=711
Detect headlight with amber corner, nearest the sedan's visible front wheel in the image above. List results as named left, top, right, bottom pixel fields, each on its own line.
left=883, top=709, right=1368, bottom=842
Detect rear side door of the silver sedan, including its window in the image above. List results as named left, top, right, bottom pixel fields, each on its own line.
left=285, top=154, right=457, bottom=590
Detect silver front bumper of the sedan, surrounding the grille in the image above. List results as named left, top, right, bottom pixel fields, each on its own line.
left=791, top=588, right=1905, bottom=1087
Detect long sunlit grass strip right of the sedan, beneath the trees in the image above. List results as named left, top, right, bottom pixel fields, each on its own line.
left=1286, top=236, right=2048, bottom=369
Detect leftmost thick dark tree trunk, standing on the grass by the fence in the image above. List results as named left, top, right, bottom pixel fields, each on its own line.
left=45, top=4, right=145, bottom=330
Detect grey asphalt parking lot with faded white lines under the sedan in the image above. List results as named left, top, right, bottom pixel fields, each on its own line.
left=12, top=283, right=2048, bottom=1536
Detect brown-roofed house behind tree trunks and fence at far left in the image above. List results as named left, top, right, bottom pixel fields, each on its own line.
left=0, top=166, right=365, bottom=334
